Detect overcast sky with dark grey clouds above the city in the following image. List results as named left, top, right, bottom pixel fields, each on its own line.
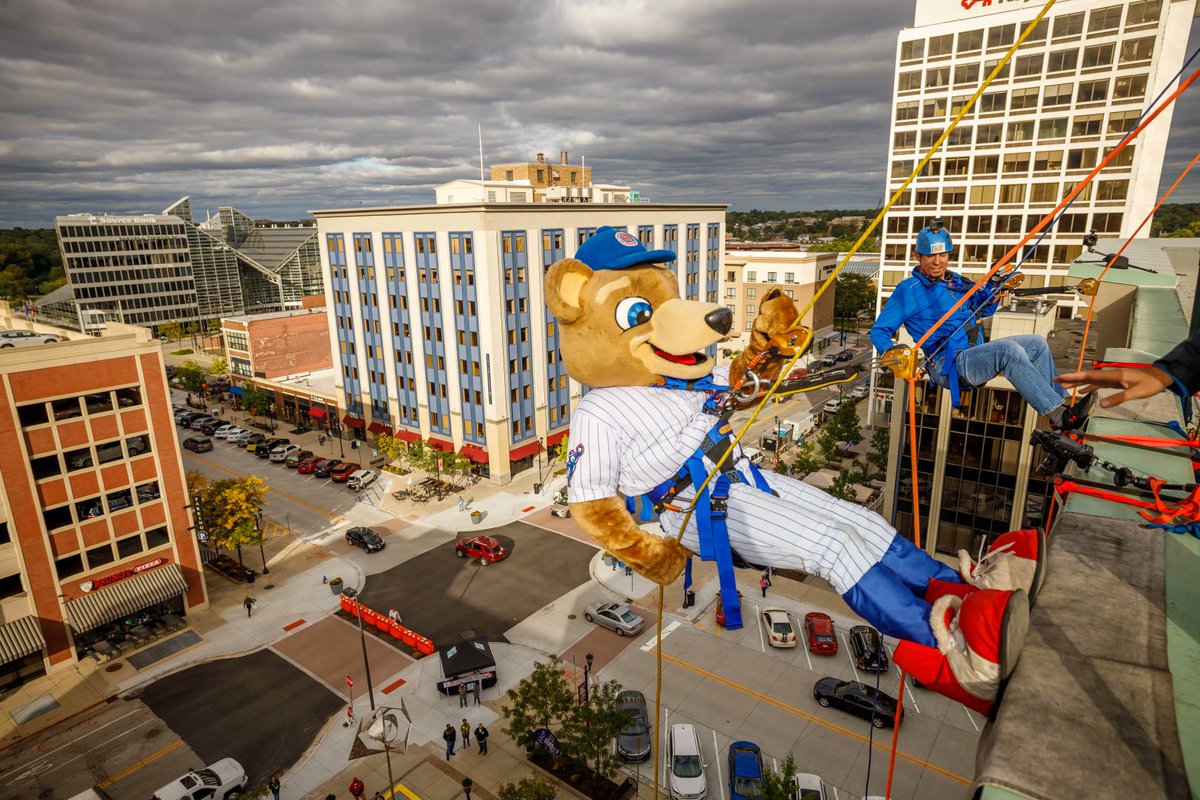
left=0, top=0, right=1200, bottom=228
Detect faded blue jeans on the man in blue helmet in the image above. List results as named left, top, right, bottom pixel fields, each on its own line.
left=950, top=333, right=1067, bottom=414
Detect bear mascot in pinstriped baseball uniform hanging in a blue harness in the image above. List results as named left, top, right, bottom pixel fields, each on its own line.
left=546, top=227, right=1046, bottom=715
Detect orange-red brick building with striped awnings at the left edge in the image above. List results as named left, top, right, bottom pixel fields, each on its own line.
left=0, top=305, right=208, bottom=690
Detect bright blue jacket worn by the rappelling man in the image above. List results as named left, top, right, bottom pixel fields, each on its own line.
left=871, top=269, right=1000, bottom=381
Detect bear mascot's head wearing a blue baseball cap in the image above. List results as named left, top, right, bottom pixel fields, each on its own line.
left=546, top=225, right=733, bottom=387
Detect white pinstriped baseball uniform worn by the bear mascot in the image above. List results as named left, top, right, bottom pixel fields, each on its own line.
left=568, top=367, right=895, bottom=594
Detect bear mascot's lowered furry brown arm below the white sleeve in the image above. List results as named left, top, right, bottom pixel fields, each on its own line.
left=571, top=498, right=691, bottom=585
